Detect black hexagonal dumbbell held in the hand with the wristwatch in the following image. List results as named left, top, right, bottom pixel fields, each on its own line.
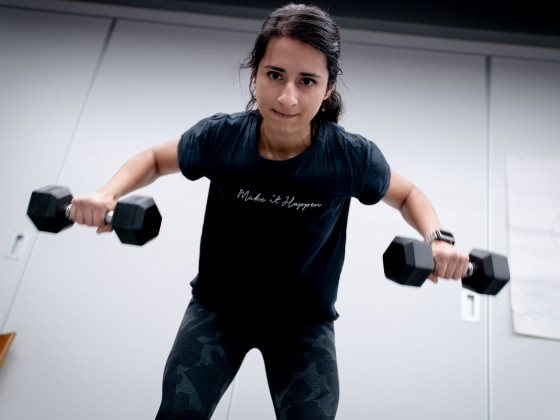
left=383, top=236, right=509, bottom=295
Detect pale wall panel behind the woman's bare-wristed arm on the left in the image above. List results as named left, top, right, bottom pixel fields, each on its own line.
left=1, top=16, right=253, bottom=420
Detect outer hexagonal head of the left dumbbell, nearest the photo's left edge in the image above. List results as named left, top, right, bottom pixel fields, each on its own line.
left=27, top=185, right=74, bottom=233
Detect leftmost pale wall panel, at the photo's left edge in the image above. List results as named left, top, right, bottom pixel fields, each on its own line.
left=0, top=2, right=111, bottom=360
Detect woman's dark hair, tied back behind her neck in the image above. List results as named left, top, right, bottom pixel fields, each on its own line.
left=242, top=3, right=342, bottom=125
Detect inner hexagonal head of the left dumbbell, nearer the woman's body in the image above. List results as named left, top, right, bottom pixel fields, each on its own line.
left=111, top=195, right=161, bottom=245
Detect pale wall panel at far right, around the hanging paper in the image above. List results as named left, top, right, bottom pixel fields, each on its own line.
left=489, top=58, right=560, bottom=420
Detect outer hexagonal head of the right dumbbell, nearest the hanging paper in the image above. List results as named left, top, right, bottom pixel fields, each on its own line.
left=462, top=249, right=510, bottom=295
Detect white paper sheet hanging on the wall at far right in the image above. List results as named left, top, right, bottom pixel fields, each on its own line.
left=507, top=156, right=560, bottom=340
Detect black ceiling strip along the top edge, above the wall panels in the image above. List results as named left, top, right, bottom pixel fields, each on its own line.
left=68, top=0, right=560, bottom=48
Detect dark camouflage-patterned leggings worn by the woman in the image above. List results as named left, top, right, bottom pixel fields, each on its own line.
left=156, top=299, right=339, bottom=420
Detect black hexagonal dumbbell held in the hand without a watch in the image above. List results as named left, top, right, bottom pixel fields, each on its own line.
left=27, top=185, right=161, bottom=245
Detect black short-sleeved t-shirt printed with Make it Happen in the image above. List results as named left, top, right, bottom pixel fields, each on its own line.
left=178, top=112, right=390, bottom=320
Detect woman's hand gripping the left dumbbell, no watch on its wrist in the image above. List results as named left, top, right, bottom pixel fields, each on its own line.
left=70, top=192, right=117, bottom=233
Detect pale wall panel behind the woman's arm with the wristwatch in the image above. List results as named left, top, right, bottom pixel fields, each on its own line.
left=336, top=42, right=488, bottom=420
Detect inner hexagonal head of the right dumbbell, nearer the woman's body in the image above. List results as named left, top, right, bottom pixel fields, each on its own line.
left=383, top=236, right=434, bottom=287
